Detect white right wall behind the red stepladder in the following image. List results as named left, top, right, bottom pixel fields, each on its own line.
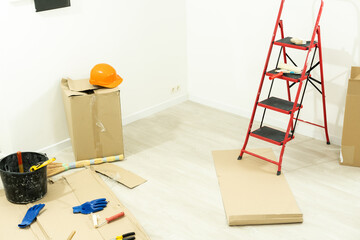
left=187, top=0, right=360, bottom=144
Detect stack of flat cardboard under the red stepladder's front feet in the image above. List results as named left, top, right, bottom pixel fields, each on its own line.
left=212, top=149, right=303, bottom=226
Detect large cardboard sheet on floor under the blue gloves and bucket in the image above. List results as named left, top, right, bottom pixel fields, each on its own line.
left=0, top=169, right=150, bottom=240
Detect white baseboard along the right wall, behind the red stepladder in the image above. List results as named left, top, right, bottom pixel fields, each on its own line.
left=189, top=95, right=341, bottom=145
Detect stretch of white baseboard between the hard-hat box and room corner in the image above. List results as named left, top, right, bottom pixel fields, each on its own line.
left=122, top=94, right=188, bottom=126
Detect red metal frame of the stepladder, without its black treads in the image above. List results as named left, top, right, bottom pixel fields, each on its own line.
left=238, top=0, right=330, bottom=175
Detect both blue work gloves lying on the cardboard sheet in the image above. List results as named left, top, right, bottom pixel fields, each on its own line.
left=18, top=198, right=108, bottom=228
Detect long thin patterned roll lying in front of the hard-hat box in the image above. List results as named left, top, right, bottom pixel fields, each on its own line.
left=47, top=154, right=124, bottom=177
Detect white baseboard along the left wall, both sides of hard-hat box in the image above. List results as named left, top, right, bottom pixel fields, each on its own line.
left=36, top=94, right=188, bottom=157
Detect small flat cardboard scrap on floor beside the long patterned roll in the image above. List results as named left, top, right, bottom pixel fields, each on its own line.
left=91, top=163, right=146, bottom=188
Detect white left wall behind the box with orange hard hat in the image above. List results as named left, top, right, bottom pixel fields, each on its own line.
left=0, top=0, right=187, bottom=154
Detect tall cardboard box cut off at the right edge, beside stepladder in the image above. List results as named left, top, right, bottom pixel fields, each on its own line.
left=340, top=67, right=360, bottom=167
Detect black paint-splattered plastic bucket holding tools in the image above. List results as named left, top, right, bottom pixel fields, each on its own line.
left=0, top=152, right=48, bottom=204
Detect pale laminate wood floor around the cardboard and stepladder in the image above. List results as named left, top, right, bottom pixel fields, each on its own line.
left=52, top=101, right=360, bottom=240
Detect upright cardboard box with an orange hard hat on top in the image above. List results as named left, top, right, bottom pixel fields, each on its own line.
left=61, top=79, right=124, bottom=160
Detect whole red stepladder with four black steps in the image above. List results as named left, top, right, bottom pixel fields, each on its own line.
left=238, top=0, right=330, bottom=175
